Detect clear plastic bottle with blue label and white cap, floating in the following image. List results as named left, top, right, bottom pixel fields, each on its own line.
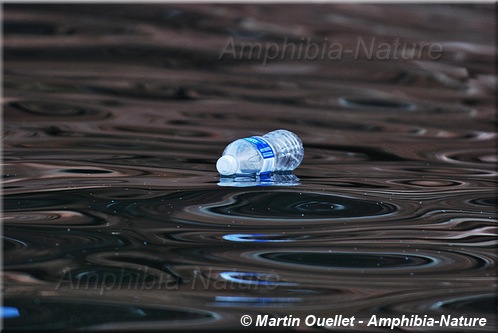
left=216, top=129, right=304, bottom=176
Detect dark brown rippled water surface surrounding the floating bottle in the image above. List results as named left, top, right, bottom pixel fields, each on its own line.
left=3, top=4, right=497, bottom=332
